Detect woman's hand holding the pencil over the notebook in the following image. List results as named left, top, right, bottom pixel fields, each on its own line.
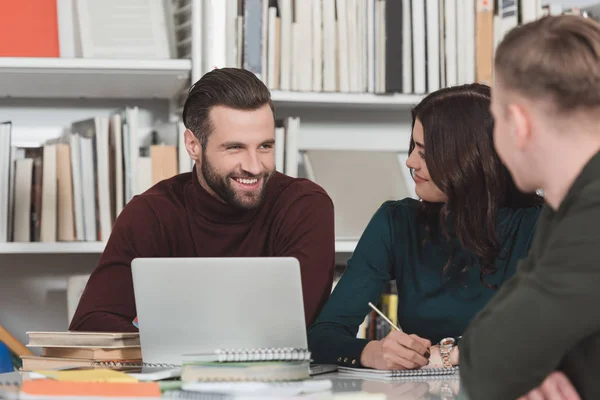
left=360, top=330, right=431, bottom=370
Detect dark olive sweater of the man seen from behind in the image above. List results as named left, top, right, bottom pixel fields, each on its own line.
left=459, top=153, right=600, bottom=400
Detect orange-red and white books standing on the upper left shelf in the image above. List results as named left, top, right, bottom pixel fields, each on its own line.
left=0, top=0, right=188, bottom=59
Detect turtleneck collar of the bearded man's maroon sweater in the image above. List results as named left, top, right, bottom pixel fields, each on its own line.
left=185, top=165, right=262, bottom=224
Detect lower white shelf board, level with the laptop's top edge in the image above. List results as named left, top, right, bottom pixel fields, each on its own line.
left=0, top=240, right=357, bottom=257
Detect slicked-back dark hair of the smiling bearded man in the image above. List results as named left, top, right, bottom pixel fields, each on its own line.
left=183, top=68, right=275, bottom=149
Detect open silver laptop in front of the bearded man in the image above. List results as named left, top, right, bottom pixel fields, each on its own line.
left=131, top=257, right=332, bottom=376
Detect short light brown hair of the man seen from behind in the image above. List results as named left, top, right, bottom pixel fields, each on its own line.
left=494, top=15, right=600, bottom=112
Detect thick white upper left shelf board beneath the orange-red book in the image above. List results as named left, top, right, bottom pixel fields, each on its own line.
left=0, top=57, right=192, bottom=99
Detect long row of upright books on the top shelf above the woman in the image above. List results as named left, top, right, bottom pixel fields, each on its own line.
left=197, top=0, right=590, bottom=94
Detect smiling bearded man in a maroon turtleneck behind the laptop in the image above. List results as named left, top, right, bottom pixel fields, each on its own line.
left=70, top=68, right=335, bottom=332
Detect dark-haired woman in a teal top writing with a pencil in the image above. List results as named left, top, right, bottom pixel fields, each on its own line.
left=308, top=84, right=543, bottom=369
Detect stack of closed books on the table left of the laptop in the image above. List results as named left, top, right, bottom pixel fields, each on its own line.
left=21, top=332, right=142, bottom=371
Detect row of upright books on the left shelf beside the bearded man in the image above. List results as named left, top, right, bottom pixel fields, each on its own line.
left=0, top=111, right=191, bottom=243
